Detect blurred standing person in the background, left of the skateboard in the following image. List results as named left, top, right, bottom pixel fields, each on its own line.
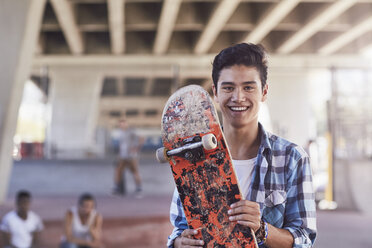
left=113, top=119, right=144, bottom=196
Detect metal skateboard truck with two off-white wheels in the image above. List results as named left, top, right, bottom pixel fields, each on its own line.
left=156, top=133, right=217, bottom=163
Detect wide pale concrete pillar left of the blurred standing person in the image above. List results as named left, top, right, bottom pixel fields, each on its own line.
left=46, top=68, right=103, bottom=159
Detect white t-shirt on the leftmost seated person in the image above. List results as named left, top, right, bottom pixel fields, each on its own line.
left=0, top=211, right=44, bottom=248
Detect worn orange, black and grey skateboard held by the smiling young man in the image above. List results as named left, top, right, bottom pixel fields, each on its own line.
left=156, top=85, right=258, bottom=248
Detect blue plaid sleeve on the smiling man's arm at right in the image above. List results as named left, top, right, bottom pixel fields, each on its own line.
left=283, top=152, right=316, bottom=248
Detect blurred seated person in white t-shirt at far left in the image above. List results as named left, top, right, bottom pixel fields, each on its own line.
left=0, top=190, right=43, bottom=248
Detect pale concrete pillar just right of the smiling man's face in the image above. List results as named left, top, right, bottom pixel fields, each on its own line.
left=267, top=68, right=315, bottom=146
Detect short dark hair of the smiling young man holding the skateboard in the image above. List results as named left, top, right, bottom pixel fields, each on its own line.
left=212, top=43, right=268, bottom=90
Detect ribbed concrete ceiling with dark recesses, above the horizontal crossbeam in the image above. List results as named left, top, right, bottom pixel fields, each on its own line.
left=37, top=0, right=372, bottom=56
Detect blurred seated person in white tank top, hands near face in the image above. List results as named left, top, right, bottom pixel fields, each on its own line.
left=60, top=193, right=103, bottom=248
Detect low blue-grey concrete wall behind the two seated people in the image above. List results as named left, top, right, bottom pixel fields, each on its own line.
left=8, top=153, right=174, bottom=197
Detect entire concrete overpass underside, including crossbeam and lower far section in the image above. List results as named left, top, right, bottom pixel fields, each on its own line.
left=34, top=0, right=372, bottom=126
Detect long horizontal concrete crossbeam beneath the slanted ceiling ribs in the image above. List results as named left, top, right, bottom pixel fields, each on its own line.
left=34, top=54, right=371, bottom=69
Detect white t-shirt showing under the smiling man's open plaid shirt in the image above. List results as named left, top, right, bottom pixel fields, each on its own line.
left=232, top=157, right=257, bottom=199
